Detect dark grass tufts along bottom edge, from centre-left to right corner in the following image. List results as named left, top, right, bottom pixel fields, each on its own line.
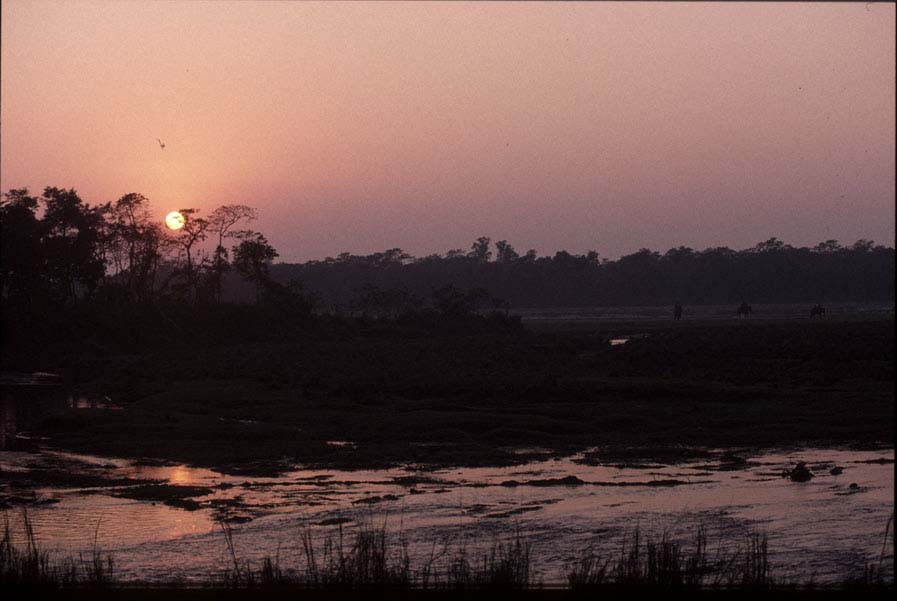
left=215, top=522, right=893, bottom=592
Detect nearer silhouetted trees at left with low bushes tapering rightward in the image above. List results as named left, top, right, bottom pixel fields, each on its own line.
left=0, top=187, right=519, bottom=368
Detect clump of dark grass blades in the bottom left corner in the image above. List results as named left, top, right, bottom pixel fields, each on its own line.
left=0, top=509, right=113, bottom=588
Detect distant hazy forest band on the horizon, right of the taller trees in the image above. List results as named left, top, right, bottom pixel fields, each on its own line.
left=227, top=237, right=894, bottom=313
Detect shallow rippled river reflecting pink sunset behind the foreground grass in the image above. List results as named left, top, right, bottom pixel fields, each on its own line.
left=0, top=449, right=894, bottom=583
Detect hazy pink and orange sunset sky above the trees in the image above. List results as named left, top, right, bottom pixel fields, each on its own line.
left=0, top=0, right=895, bottom=261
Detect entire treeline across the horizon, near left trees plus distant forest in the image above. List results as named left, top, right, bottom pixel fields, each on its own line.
left=0, top=187, right=894, bottom=326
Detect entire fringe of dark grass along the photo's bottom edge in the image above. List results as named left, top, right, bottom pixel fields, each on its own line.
left=0, top=512, right=894, bottom=598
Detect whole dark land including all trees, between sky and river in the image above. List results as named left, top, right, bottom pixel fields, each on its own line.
left=0, top=187, right=895, bottom=478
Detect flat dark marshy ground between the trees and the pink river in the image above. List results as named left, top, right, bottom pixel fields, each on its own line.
left=31, top=320, right=894, bottom=473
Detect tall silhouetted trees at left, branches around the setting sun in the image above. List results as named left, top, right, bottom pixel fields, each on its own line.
left=0, top=187, right=294, bottom=313
